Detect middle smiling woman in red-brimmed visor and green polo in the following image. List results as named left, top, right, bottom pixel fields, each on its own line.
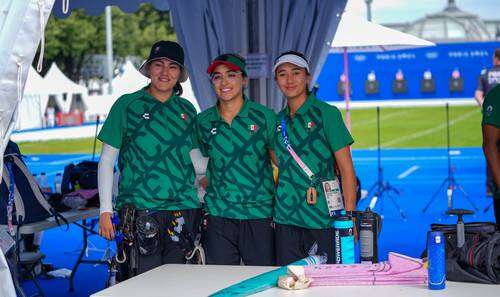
left=196, top=54, right=275, bottom=265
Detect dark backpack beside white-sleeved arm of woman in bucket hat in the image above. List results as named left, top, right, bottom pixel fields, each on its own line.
left=61, top=161, right=99, bottom=195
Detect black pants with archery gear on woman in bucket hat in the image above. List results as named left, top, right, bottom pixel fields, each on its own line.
left=120, top=209, right=201, bottom=280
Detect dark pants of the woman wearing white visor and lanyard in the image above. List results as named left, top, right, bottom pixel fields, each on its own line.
left=274, top=223, right=334, bottom=266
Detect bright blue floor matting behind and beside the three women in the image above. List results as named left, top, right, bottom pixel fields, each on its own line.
left=18, top=148, right=494, bottom=297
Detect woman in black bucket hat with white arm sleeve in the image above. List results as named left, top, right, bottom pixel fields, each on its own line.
left=98, top=41, right=201, bottom=276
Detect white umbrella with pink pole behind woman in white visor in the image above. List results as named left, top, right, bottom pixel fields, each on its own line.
left=330, top=13, right=436, bottom=130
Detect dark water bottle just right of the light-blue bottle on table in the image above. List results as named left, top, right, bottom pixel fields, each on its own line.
left=359, top=208, right=379, bottom=263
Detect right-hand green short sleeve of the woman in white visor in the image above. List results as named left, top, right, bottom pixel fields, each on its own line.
left=322, top=106, right=354, bottom=153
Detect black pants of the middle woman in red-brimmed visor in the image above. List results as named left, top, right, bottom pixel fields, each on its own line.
left=203, top=215, right=275, bottom=266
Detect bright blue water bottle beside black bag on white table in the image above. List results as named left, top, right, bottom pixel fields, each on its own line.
left=427, top=231, right=446, bottom=290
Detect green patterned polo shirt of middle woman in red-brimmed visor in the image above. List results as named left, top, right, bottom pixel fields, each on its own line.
left=196, top=99, right=276, bottom=219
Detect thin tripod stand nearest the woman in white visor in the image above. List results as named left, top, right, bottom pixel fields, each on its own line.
left=368, top=106, right=406, bottom=220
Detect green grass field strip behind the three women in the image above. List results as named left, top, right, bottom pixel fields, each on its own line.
left=19, top=106, right=482, bottom=154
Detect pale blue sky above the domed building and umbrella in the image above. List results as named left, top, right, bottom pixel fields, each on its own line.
left=346, top=0, right=500, bottom=24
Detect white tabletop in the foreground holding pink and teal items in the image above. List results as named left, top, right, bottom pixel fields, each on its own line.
left=91, top=264, right=500, bottom=297
